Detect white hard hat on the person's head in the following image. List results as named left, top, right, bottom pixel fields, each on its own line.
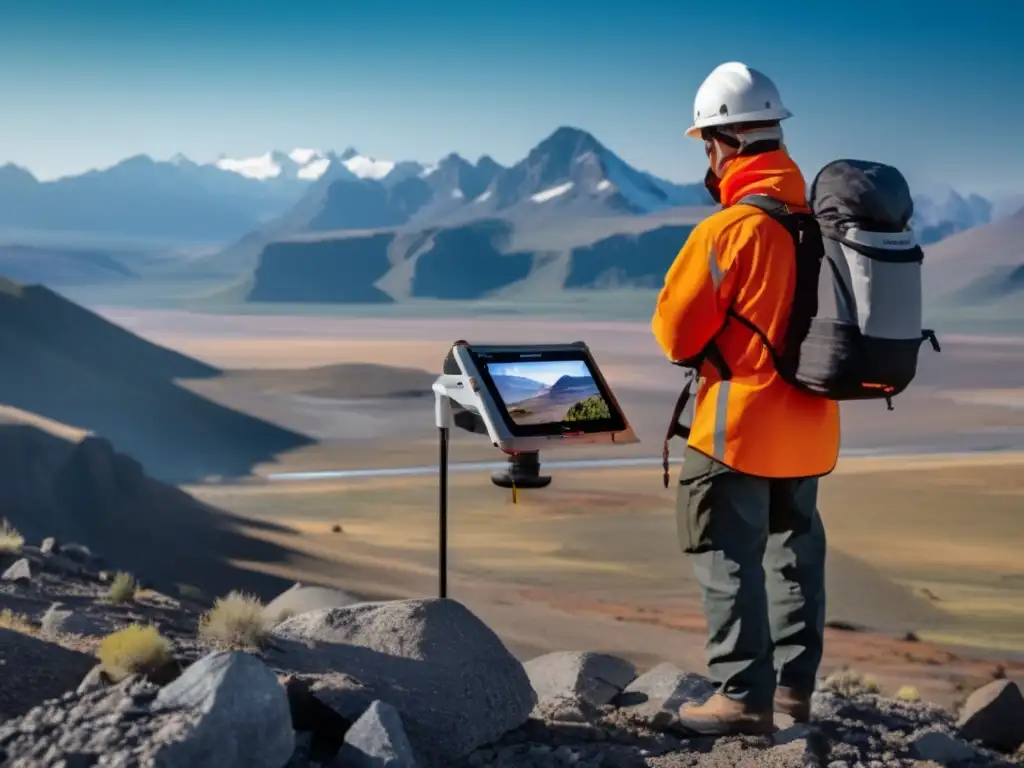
left=686, top=61, right=793, bottom=138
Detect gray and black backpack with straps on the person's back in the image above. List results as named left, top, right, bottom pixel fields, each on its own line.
left=663, top=160, right=939, bottom=486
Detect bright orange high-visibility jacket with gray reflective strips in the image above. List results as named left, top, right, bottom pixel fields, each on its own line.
left=651, top=150, right=839, bottom=477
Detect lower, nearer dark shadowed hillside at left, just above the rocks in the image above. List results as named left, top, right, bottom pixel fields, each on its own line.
left=0, top=426, right=331, bottom=598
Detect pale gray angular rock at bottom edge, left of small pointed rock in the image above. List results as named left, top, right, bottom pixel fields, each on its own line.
left=152, top=652, right=295, bottom=768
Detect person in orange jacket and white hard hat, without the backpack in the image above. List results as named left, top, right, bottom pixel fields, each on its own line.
left=651, top=62, right=839, bottom=735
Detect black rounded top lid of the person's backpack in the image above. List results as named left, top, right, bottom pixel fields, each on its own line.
left=809, top=160, right=913, bottom=239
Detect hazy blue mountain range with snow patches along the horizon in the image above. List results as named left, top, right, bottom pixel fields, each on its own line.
left=0, top=127, right=1020, bottom=319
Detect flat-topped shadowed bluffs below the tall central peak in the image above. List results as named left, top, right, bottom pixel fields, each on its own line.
left=238, top=215, right=693, bottom=303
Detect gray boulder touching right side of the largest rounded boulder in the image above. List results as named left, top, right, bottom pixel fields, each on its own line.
left=523, top=651, right=637, bottom=707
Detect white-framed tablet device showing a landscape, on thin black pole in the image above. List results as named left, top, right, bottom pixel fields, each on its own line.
left=432, top=340, right=639, bottom=598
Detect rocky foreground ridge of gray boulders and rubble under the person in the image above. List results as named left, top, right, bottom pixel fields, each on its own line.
left=0, top=536, right=1024, bottom=768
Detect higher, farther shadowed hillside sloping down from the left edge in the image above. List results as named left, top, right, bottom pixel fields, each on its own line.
left=0, top=281, right=313, bottom=482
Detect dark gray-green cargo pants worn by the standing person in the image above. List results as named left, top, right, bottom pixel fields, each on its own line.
left=676, top=447, right=825, bottom=710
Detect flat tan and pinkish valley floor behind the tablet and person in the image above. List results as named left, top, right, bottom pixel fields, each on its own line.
left=99, top=309, right=1024, bottom=703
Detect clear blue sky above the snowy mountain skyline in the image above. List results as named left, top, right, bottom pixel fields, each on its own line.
left=0, top=0, right=1024, bottom=194
